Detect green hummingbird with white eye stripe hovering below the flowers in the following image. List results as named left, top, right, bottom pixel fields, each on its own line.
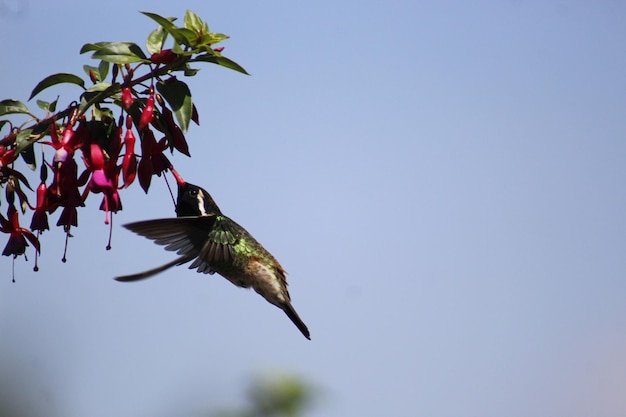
left=115, top=168, right=311, bottom=340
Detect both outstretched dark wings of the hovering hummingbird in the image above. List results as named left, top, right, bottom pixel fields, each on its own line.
left=115, top=216, right=215, bottom=281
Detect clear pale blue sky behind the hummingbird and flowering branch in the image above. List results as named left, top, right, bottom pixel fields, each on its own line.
left=0, top=0, right=626, bottom=417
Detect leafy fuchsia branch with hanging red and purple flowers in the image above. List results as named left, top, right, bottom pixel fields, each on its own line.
left=0, top=11, right=246, bottom=276
